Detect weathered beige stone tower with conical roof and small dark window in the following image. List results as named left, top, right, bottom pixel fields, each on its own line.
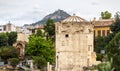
left=55, top=15, right=99, bottom=71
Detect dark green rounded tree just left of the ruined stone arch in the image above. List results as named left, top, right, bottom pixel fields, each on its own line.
left=8, top=32, right=17, bottom=46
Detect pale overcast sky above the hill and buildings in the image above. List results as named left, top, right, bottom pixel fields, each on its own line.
left=0, top=0, right=120, bottom=26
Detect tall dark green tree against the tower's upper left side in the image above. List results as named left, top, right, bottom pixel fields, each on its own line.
left=44, top=19, right=55, bottom=41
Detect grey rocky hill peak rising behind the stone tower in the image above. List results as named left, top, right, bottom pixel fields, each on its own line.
left=34, top=9, right=70, bottom=25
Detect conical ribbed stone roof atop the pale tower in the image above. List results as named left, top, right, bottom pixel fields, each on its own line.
left=62, top=14, right=87, bottom=23
